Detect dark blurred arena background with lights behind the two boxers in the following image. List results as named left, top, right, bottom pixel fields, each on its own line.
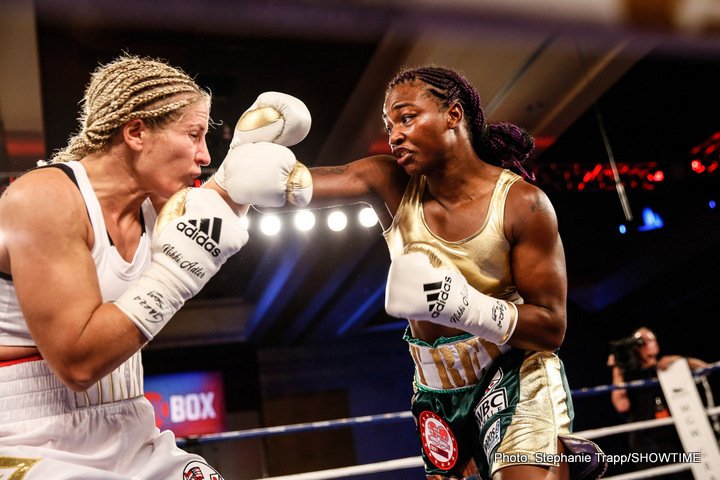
left=0, top=0, right=720, bottom=480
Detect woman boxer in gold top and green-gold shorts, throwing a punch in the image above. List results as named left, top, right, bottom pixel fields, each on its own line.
left=310, top=66, right=604, bottom=480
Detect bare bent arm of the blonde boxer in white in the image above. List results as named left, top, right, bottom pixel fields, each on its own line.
left=0, top=169, right=147, bottom=389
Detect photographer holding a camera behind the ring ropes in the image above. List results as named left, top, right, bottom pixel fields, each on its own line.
left=608, top=327, right=708, bottom=478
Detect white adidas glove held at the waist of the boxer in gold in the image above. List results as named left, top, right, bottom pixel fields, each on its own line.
left=385, top=252, right=517, bottom=345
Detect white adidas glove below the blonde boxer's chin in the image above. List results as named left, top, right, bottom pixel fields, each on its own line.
left=115, top=188, right=248, bottom=340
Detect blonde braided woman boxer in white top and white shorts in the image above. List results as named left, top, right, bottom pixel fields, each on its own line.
left=0, top=55, right=310, bottom=480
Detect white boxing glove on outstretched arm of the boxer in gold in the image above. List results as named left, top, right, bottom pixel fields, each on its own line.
left=213, top=142, right=312, bottom=207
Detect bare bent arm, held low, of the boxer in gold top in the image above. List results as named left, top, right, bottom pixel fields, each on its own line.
left=505, top=181, right=567, bottom=351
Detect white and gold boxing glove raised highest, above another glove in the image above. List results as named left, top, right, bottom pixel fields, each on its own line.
left=230, top=92, right=312, bottom=149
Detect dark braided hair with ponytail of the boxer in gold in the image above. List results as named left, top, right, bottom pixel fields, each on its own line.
left=386, top=65, right=535, bottom=180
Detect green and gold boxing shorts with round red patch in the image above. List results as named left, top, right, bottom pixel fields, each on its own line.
left=406, top=336, right=606, bottom=480
